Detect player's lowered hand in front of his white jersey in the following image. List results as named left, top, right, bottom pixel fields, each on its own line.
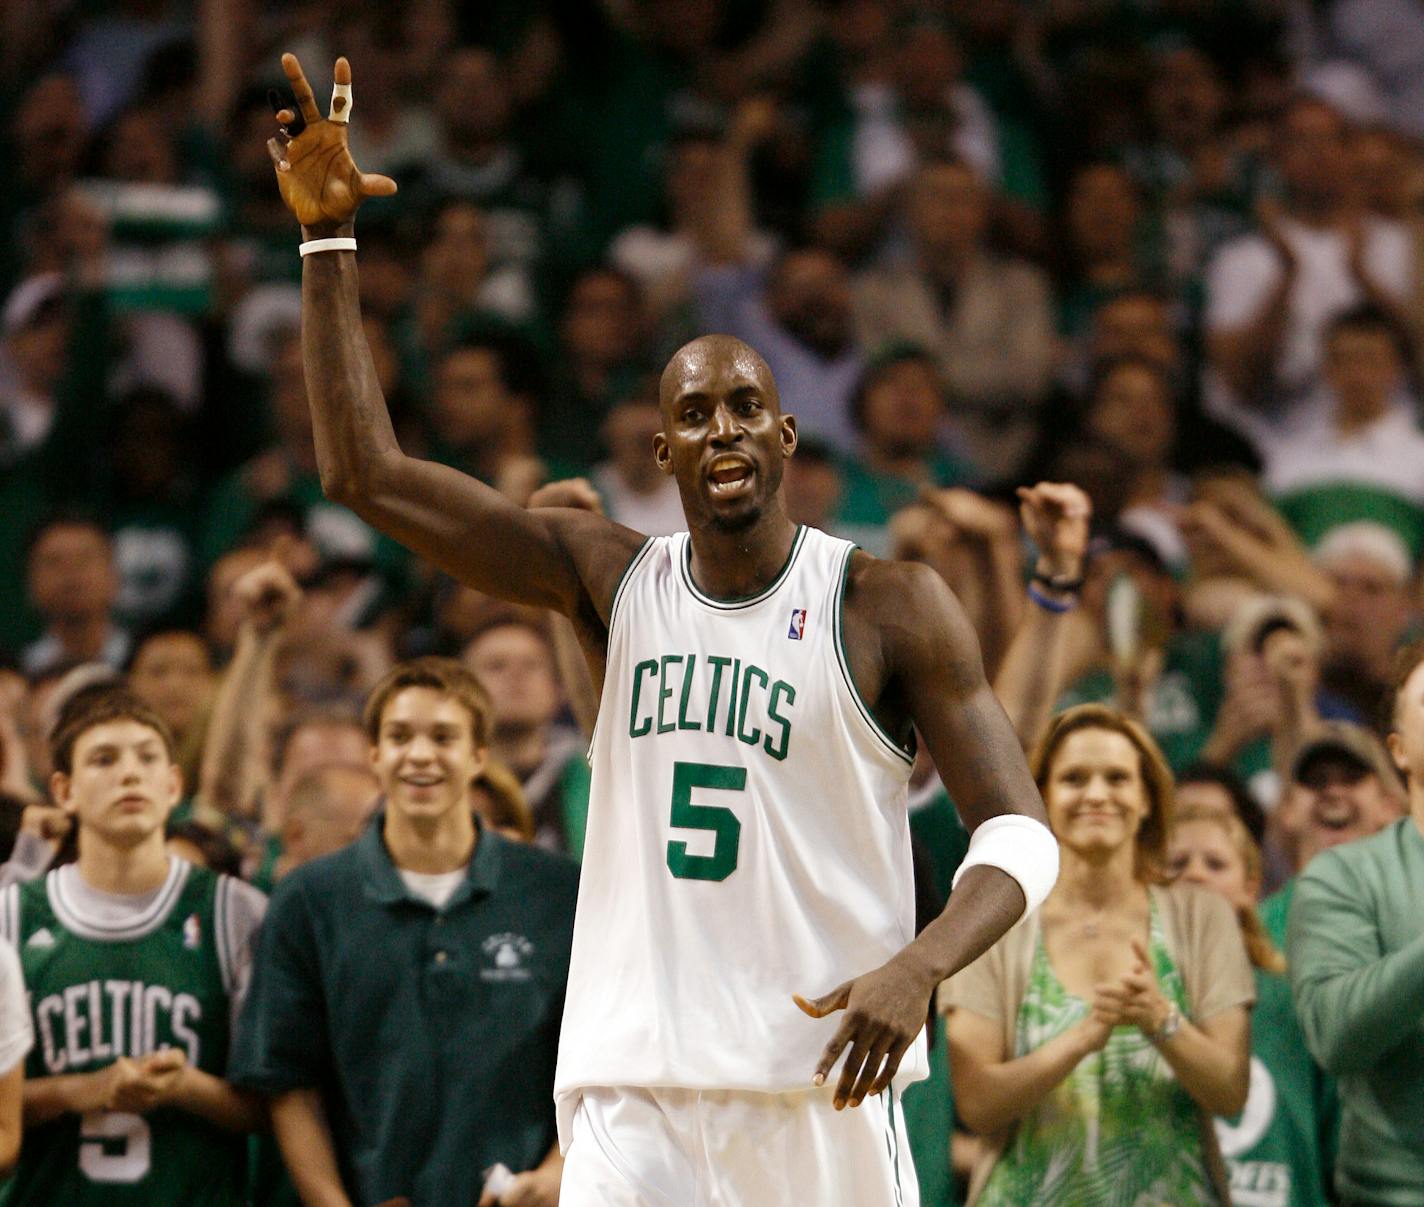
left=793, top=955, right=936, bottom=1110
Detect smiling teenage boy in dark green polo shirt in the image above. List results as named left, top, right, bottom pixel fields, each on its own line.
left=232, top=658, right=578, bottom=1207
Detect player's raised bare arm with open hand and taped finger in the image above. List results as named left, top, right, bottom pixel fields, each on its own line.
left=268, top=54, right=641, bottom=621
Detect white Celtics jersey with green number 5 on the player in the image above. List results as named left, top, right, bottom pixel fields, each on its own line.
left=554, top=527, right=928, bottom=1144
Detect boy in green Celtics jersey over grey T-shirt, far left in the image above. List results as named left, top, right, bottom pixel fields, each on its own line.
left=0, top=687, right=263, bottom=1207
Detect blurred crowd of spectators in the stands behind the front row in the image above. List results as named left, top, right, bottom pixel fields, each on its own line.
left=0, top=0, right=1424, bottom=1204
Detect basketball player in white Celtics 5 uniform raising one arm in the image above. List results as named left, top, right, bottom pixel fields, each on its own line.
left=269, top=56, right=1057, bottom=1207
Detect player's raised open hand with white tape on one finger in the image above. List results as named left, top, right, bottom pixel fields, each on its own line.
left=268, top=54, right=396, bottom=232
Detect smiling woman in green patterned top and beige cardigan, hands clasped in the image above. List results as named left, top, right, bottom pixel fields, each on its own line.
left=940, top=705, right=1255, bottom=1207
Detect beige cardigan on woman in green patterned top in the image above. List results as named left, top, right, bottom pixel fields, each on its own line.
left=938, top=885, right=1256, bottom=1207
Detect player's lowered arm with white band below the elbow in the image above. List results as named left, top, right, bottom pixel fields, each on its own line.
left=797, top=555, right=1058, bottom=1107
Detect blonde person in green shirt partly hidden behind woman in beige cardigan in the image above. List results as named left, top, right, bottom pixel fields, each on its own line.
left=1168, top=806, right=1337, bottom=1207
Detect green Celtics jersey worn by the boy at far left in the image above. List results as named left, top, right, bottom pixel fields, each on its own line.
left=0, top=858, right=251, bottom=1207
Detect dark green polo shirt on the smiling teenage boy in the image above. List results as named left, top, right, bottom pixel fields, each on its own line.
left=229, top=814, right=578, bottom=1207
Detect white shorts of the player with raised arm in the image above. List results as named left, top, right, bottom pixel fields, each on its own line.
left=558, top=1086, right=920, bottom=1207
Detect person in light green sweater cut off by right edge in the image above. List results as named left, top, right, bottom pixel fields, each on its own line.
left=1287, top=646, right=1424, bottom=1207
